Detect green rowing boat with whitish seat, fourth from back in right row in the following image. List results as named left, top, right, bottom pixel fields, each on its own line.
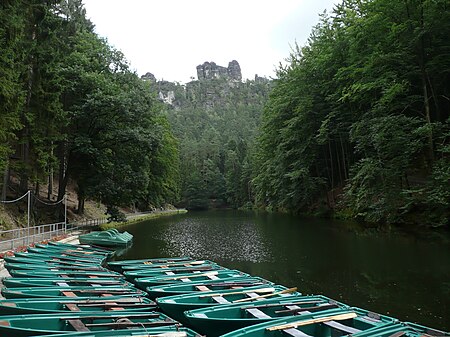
left=134, top=270, right=249, bottom=289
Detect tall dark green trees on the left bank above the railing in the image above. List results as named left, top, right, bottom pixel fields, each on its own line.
left=0, top=0, right=179, bottom=223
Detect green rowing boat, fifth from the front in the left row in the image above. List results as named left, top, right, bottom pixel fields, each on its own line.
left=2, top=277, right=132, bottom=288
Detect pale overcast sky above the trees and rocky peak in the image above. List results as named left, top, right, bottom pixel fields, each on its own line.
left=83, top=0, right=338, bottom=82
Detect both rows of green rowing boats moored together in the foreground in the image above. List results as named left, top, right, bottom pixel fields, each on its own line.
left=0, top=238, right=450, bottom=337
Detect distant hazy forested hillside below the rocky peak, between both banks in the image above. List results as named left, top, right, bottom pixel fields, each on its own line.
left=151, top=70, right=270, bottom=209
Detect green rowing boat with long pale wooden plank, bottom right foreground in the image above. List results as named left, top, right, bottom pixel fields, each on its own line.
left=218, top=308, right=396, bottom=337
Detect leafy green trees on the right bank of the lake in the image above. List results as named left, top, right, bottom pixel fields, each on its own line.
left=254, top=0, right=450, bottom=225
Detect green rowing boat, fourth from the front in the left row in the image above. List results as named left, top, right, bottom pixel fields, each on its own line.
left=1, top=286, right=147, bottom=299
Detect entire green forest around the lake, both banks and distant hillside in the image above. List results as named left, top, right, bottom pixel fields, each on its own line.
left=0, top=0, right=450, bottom=226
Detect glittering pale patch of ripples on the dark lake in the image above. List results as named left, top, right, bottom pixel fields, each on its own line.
left=156, top=218, right=273, bottom=263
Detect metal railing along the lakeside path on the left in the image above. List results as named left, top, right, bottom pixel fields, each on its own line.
left=0, top=218, right=107, bottom=252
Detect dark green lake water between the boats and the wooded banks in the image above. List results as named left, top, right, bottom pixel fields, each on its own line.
left=120, top=211, right=450, bottom=331
